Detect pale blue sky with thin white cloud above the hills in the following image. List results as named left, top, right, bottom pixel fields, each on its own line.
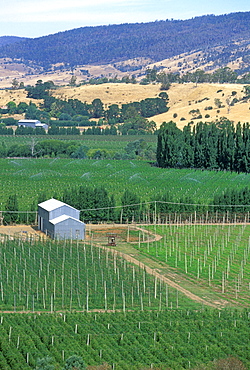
left=0, top=0, right=250, bottom=37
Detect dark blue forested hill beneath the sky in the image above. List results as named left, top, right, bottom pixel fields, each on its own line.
left=0, top=12, right=250, bottom=68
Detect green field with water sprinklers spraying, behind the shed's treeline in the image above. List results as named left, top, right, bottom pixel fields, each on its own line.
left=0, top=158, right=250, bottom=210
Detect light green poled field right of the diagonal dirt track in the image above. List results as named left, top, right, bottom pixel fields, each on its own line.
left=137, top=223, right=250, bottom=306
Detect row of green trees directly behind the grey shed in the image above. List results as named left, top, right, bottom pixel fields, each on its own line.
left=3, top=185, right=250, bottom=225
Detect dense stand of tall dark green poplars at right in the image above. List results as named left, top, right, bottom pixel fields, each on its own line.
left=156, top=119, right=250, bottom=172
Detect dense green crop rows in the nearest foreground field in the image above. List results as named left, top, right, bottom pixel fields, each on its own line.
left=0, top=310, right=250, bottom=370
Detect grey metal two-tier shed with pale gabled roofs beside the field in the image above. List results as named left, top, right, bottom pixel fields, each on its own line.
left=38, top=198, right=85, bottom=240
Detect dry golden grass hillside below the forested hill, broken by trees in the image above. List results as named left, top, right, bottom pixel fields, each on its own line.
left=0, top=83, right=250, bottom=128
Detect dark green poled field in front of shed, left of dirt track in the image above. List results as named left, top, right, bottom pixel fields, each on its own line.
left=0, top=237, right=199, bottom=312
